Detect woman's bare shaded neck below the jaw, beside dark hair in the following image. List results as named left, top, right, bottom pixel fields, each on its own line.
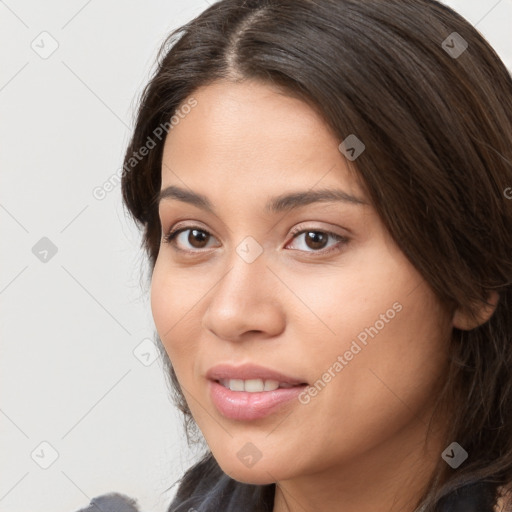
left=273, top=412, right=446, bottom=512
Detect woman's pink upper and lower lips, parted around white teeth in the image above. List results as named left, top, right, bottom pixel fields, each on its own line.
left=206, top=364, right=306, bottom=421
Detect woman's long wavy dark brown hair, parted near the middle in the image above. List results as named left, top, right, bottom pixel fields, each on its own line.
left=122, top=0, right=512, bottom=512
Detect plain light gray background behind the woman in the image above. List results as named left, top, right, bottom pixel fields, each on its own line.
left=0, top=0, right=512, bottom=512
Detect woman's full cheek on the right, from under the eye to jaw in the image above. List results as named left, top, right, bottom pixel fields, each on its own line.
left=288, top=252, right=451, bottom=432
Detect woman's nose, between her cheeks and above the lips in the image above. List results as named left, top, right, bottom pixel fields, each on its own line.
left=202, top=246, right=285, bottom=342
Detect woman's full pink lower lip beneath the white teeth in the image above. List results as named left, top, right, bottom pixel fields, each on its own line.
left=210, top=380, right=306, bottom=421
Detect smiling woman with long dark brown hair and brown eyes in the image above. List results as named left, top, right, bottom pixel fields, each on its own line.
left=79, top=0, right=512, bottom=512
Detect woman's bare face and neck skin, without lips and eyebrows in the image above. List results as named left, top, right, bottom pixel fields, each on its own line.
left=151, top=82, right=496, bottom=512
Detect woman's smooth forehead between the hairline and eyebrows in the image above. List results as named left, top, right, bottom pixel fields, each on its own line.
left=162, top=81, right=362, bottom=201
